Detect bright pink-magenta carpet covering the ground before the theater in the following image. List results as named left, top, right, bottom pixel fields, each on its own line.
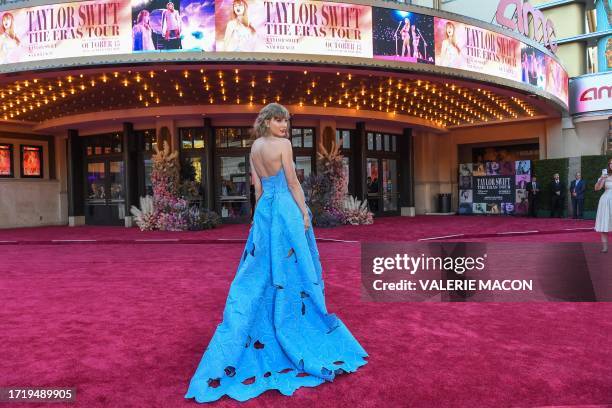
left=0, top=217, right=612, bottom=407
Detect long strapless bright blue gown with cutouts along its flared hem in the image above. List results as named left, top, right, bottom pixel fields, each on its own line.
left=185, top=168, right=368, bottom=402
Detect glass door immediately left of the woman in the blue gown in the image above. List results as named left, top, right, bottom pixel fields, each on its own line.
left=217, top=155, right=251, bottom=222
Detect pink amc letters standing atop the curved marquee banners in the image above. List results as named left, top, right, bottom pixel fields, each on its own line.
left=495, top=0, right=557, bottom=52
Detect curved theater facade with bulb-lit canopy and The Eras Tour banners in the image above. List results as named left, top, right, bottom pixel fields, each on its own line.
left=0, top=0, right=572, bottom=227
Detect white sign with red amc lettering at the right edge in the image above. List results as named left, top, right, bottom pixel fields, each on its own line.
left=570, top=72, right=612, bottom=115
